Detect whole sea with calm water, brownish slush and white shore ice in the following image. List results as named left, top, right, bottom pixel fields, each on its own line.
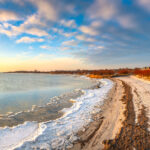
left=0, top=73, right=113, bottom=150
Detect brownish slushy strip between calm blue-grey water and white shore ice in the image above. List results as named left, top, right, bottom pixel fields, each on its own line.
left=0, top=75, right=97, bottom=128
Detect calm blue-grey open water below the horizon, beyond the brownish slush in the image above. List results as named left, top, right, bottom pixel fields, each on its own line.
left=0, top=73, right=93, bottom=114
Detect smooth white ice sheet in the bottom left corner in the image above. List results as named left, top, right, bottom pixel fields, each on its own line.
left=0, top=122, right=46, bottom=150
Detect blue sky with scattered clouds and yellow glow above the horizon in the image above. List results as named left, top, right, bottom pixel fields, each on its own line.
left=0, top=0, right=150, bottom=72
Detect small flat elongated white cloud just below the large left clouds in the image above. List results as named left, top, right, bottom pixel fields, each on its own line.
left=16, top=37, right=44, bottom=43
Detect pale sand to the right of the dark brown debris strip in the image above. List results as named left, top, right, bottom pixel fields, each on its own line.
left=120, top=76, right=150, bottom=131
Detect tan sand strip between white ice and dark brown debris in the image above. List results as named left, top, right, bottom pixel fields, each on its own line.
left=70, top=80, right=125, bottom=150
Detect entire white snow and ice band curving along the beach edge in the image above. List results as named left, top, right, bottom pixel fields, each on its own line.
left=0, top=79, right=113, bottom=150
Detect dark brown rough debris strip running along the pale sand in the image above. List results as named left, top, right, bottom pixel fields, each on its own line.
left=103, top=81, right=150, bottom=150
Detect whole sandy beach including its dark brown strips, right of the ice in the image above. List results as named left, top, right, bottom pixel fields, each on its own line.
left=71, top=77, right=150, bottom=150
